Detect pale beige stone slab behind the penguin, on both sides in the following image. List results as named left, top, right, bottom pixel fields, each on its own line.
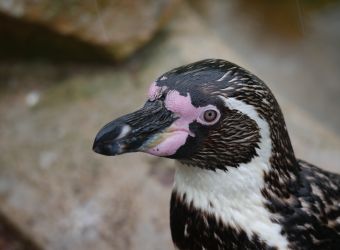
left=0, top=0, right=340, bottom=250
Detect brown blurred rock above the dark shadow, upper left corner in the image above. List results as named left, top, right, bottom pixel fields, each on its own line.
left=0, top=0, right=178, bottom=60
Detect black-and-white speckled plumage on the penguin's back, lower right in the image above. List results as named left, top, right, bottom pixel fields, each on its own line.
left=263, top=160, right=340, bottom=249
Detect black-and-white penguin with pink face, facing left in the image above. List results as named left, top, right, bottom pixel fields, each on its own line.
left=93, top=59, right=340, bottom=250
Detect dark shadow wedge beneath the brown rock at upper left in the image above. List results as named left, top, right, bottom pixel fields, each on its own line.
left=0, top=13, right=113, bottom=63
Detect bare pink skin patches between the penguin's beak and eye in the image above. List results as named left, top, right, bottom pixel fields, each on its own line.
left=145, top=88, right=217, bottom=156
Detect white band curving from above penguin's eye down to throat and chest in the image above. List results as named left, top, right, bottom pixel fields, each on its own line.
left=174, top=96, right=288, bottom=249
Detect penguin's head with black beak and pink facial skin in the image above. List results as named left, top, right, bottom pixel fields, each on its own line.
left=93, top=59, right=291, bottom=169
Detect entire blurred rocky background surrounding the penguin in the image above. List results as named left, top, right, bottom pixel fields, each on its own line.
left=0, top=0, right=340, bottom=250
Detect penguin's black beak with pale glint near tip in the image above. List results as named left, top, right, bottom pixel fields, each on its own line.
left=93, top=100, right=175, bottom=155
